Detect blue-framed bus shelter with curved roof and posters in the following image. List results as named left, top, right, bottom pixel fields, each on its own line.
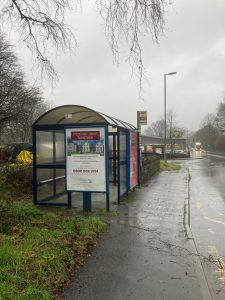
left=32, top=105, right=140, bottom=211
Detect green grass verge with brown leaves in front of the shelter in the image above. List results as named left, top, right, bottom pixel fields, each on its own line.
left=0, top=200, right=107, bottom=300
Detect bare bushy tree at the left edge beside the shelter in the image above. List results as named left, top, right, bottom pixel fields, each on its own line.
left=0, top=35, right=49, bottom=141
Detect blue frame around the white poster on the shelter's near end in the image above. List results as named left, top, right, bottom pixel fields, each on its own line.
left=64, top=124, right=109, bottom=194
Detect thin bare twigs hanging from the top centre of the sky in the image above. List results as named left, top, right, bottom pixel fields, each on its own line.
left=96, top=0, right=168, bottom=90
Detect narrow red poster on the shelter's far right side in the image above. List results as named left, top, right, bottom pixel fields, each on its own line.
left=130, top=132, right=138, bottom=189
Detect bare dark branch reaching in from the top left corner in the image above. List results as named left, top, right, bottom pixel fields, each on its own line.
left=0, top=0, right=76, bottom=81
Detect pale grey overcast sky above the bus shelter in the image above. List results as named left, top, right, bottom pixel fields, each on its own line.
left=11, top=0, right=225, bottom=130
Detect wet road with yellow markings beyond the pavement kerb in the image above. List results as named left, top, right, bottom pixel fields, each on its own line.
left=187, top=155, right=225, bottom=300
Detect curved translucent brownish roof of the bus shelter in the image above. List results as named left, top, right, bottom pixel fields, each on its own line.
left=33, top=105, right=136, bottom=130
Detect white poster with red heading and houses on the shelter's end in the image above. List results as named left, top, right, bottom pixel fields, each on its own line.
left=66, top=127, right=106, bottom=192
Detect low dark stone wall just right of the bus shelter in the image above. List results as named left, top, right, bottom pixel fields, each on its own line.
left=140, top=153, right=160, bottom=183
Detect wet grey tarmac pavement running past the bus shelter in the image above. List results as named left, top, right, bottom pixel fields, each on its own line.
left=64, top=160, right=207, bottom=300
